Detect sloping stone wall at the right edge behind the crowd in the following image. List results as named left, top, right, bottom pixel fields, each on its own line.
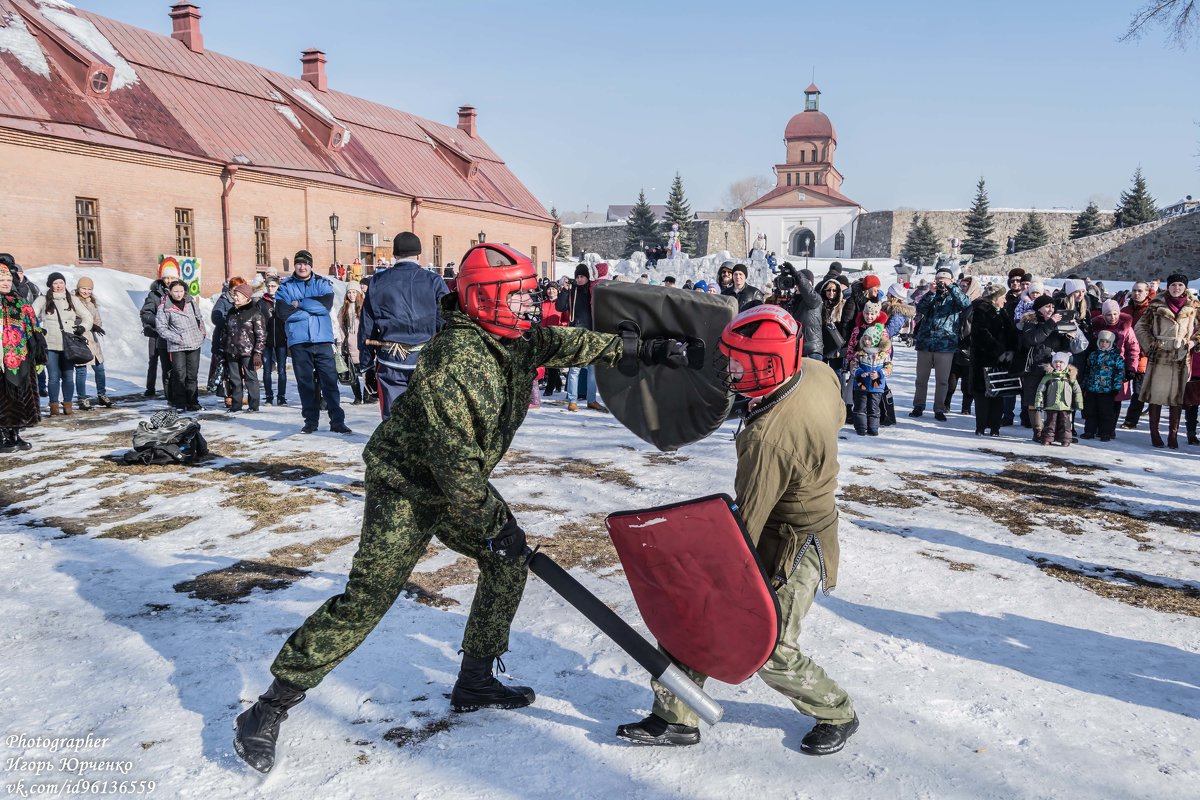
left=968, top=212, right=1200, bottom=281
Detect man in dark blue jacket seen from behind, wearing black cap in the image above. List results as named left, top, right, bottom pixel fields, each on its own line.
left=359, top=230, right=446, bottom=420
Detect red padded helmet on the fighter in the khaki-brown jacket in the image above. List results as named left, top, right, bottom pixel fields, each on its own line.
left=718, top=305, right=804, bottom=397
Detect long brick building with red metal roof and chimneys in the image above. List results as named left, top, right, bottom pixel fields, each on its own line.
left=0, top=0, right=553, bottom=294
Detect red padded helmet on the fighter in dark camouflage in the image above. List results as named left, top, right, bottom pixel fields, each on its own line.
left=455, top=242, right=541, bottom=339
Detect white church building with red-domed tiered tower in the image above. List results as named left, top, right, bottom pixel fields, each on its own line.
left=744, top=84, right=863, bottom=261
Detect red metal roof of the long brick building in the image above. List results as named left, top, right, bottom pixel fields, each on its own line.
left=0, top=0, right=550, bottom=221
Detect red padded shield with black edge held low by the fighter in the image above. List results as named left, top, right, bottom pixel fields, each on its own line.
left=605, top=494, right=780, bottom=684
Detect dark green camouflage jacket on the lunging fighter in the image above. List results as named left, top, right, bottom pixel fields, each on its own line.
left=362, top=294, right=620, bottom=540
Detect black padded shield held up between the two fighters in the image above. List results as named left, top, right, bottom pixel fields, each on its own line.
left=593, top=281, right=738, bottom=451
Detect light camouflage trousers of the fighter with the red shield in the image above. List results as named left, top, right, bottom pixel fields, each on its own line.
left=650, top=547, right=854, bottom=727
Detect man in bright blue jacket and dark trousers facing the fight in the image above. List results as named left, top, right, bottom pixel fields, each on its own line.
left=275, top=249, right=353, bottom=433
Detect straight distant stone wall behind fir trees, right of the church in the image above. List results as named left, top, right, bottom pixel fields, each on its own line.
left=853, top=209, right=1112, bottom=258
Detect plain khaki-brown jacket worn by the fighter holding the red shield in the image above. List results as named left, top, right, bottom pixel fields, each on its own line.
left=734, top=359, right=846, bottom=593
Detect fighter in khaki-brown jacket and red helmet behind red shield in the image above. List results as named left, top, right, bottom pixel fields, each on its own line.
left=617, top=306, right=858, bottom=756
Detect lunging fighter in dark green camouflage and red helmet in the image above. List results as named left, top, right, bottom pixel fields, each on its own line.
left=234, top=243, right=685, bottom=772
